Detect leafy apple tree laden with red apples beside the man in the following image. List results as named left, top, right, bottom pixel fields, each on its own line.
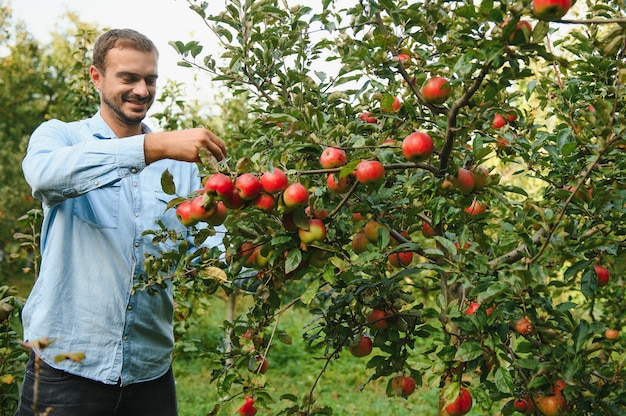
left=147, top=0, right=626, bottom=415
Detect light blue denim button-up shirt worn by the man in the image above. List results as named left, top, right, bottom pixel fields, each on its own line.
left=22, top=113, right=219, bottom=385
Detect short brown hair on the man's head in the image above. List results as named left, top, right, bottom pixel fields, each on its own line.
left=92, top=29, right=159, bottom=71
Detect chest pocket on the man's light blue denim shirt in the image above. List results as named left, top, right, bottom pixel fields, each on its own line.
left=73, top=183, right=120, bottom=228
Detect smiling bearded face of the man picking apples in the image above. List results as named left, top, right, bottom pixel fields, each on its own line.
left=90, top=48, right=158, bottom=127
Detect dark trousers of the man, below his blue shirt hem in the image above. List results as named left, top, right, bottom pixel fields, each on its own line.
left=15, top=354, right=178, bottom=416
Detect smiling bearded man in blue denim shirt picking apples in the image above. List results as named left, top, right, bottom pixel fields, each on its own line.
left=17, top=29, right=226, bottom=416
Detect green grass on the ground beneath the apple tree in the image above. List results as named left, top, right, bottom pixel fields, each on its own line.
left=174, top=292, right=472, bottom=416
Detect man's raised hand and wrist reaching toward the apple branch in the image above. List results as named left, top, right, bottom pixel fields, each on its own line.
left=144, top=128, right=226, bottom=165
